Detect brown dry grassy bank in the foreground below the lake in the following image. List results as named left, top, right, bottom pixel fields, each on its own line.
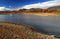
left=0, top=22, right=57, bottom=39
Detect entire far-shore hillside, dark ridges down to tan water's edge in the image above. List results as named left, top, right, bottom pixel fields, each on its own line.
left=0, top=6, right=60, bottom=16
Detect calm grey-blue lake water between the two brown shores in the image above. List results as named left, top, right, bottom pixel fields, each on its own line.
left=0, top=14, right=60, bottom=35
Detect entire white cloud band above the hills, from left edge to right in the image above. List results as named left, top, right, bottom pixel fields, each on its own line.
left=0, top=0, right=60, bottom=11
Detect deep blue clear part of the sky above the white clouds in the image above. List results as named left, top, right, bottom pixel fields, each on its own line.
left=0, top=0, right=49, bottom=8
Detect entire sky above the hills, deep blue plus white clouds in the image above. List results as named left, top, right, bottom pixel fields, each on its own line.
left=0, top=0, right=60, bottom=11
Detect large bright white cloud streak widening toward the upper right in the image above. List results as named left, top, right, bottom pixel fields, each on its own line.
left=22, top=0, right=60, bottom=9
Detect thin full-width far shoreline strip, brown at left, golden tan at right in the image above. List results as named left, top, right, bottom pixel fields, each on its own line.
left=0, top=12, right=60, bottom=17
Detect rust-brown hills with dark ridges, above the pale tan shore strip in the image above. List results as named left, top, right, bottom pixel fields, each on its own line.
left=0, top=8, right=60, bottom=14
